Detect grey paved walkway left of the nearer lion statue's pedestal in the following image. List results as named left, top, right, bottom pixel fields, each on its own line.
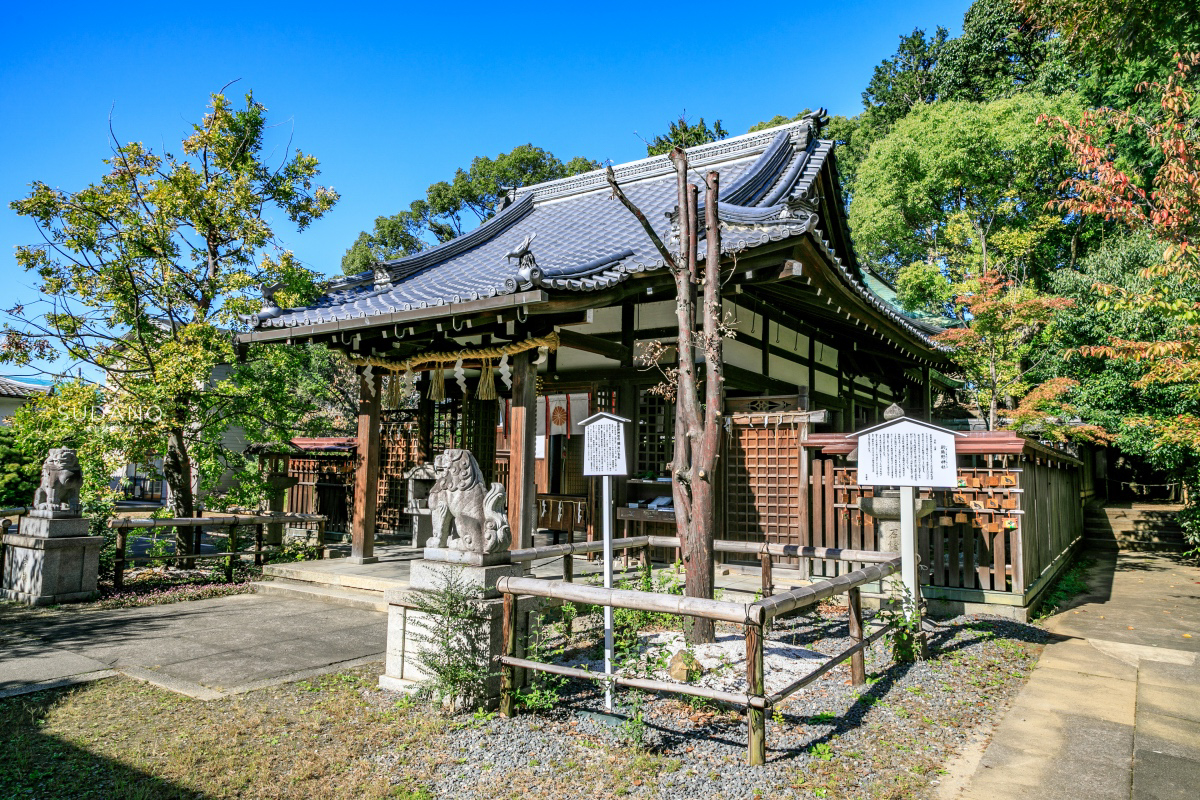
left=0, top=595, right=388, bottom=699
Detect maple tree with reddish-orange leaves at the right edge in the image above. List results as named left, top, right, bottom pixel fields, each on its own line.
left=1040, top=54, right=1200, bottom=449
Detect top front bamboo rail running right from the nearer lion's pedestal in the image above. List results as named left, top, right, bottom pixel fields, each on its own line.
left=496, top=577, right=763, bottom=625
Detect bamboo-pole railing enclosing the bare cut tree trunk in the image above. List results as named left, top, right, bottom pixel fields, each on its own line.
left=496, top=554, right=900, bottom=765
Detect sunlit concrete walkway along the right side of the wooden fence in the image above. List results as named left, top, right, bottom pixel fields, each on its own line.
left=942, top=552, right=1200, bottom=800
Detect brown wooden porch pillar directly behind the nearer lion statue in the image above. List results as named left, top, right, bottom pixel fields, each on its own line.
left=509, top=350, right=538, bottom=549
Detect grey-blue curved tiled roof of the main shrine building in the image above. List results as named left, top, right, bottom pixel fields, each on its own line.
left=247, top=119, right=929, bottom=343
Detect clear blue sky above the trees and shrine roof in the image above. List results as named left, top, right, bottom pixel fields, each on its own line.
left=0, top=0, right=970, bottom=376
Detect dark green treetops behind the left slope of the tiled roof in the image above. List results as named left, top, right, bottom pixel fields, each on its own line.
left=342, top=144, right=600, bottom=275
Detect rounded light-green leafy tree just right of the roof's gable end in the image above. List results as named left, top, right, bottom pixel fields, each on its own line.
left=848, top=95, right=1079, bottom=293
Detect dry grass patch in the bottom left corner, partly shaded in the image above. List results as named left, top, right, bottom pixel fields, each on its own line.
left=0, top=664, right=437, bottom=800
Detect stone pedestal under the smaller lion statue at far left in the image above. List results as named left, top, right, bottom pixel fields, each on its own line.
left=0, top=532, right=104, bottom=606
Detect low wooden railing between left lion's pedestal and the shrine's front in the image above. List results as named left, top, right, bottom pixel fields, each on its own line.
left=108, top=513, right=325, bottom=589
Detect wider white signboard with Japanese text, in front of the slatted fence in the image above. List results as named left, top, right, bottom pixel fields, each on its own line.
left=858, top=419, right=959, bottom=488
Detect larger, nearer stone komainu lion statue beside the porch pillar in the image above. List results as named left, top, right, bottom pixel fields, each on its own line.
left=425, top=450, right=512, bottom=555
